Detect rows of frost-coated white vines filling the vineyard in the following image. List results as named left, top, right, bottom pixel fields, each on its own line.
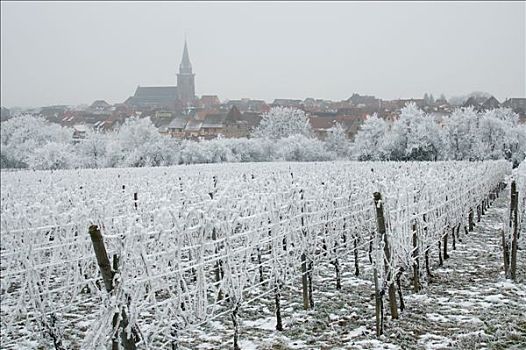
left=0, top=161, right=526, bottom=349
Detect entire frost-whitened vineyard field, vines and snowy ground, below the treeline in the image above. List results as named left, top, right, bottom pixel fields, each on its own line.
left=1, top=161, right=526, bottom=349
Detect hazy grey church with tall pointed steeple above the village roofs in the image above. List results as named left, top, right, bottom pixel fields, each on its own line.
left=124, top=40, right=196, bottom=111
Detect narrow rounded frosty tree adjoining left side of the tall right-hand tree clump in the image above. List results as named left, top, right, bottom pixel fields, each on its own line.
left=351, top=113, right=388, bottom=161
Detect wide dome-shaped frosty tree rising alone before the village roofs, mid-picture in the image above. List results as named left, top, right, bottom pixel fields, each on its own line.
left=252, top=107, right=312, bottom=140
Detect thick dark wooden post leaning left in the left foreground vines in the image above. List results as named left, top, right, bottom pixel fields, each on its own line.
left=88, top=225, right=139, bottom=350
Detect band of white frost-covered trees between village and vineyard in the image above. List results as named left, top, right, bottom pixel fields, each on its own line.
left=0, top=104, right=526, bottom=169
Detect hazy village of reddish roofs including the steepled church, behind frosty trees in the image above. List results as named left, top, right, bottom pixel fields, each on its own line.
left=1, top=42, right=526, bottom=140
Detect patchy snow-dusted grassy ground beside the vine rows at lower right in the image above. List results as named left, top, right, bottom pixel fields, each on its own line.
left=181, top=193, right=526, bottom=350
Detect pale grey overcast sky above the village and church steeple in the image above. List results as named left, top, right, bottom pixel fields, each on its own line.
left=1, top=1, right=526, bottom=107
